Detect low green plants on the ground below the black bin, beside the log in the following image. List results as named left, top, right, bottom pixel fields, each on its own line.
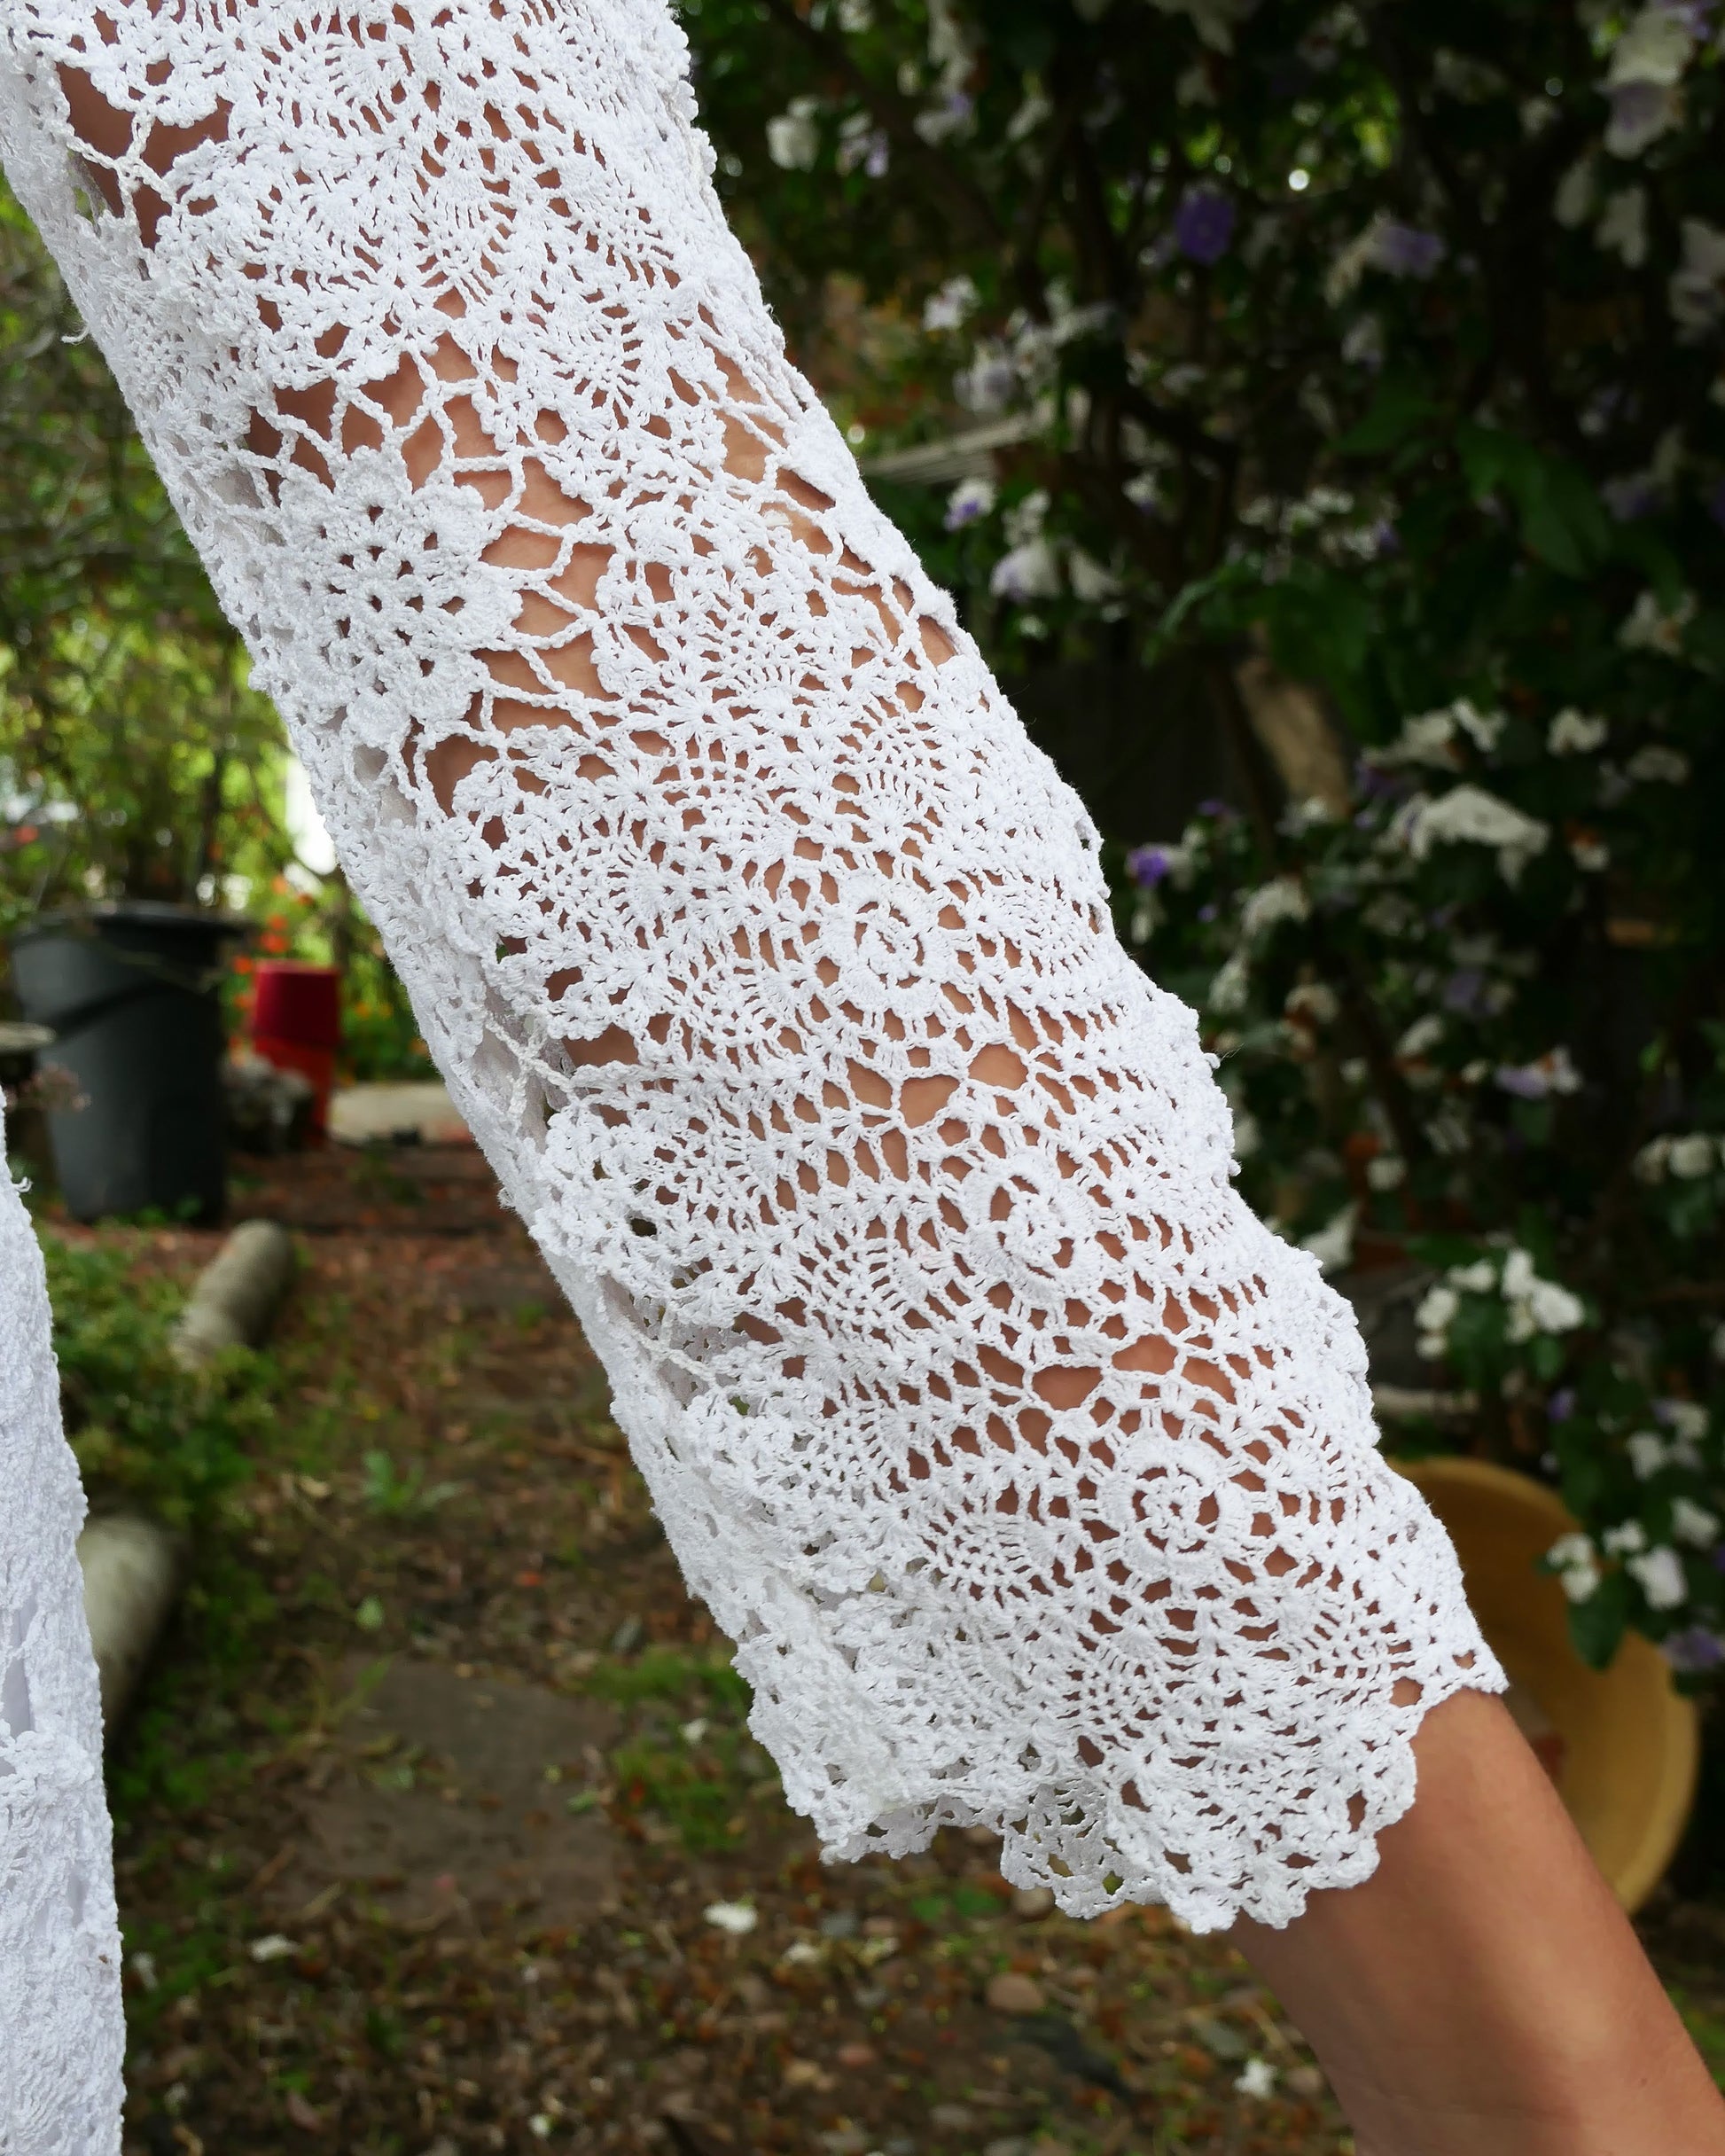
left=41, top=1231, right=271, bottom=1527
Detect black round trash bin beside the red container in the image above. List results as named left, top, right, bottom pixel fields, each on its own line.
left=13, top=899, right=248, bottom=1223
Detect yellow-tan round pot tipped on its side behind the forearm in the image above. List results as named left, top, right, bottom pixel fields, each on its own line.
left=1395, top=1457, right=1699, bottom=1912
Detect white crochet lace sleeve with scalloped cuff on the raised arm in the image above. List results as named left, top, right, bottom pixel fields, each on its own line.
left=0, top=0, right=1501, bottom=1957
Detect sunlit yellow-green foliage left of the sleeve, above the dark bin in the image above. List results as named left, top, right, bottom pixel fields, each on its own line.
left=0, top=188, right=289, bottom=933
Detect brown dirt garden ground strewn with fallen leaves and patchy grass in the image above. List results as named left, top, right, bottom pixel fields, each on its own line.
left=87, top=1147, right=1725, bottom=2156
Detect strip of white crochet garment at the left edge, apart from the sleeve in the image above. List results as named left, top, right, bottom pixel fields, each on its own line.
left=0, top=1121, right=123, bottom=2156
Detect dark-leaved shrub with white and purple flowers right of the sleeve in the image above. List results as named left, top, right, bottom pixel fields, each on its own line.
left=683, top=0, right=1725, bottom=1673
